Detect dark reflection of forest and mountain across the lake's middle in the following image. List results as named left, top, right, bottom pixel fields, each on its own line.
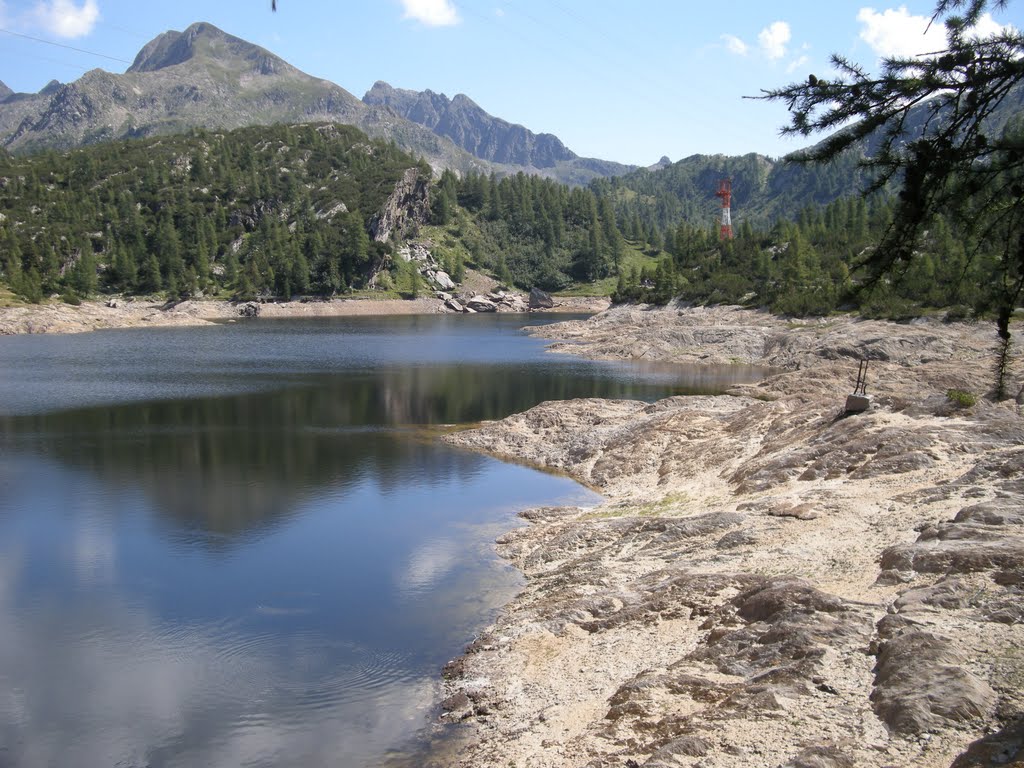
left=0, top=362, right=761, bottom=545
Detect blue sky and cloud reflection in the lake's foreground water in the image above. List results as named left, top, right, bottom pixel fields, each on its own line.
left=0, top=455, right=586, bottom=768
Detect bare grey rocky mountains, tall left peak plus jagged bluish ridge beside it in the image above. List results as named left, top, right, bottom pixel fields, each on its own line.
left=0, top=23, right=634, bottom=184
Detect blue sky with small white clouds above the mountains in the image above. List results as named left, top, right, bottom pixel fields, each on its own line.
left=0, top=0, right=1024, bottom=165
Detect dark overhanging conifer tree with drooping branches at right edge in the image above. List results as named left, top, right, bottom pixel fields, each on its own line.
left=763, top=0, right=1024, bottom=398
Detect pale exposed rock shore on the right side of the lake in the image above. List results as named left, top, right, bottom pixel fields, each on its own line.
left=436, top=308, right=1024, bottom=768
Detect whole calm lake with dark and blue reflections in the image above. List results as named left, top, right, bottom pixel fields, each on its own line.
left=0, top=315, right=761, bottom=768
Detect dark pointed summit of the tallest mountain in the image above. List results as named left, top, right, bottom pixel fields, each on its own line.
left=128, top=22, right=292, bottom=75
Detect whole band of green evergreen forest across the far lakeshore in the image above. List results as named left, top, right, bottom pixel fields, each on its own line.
left=0, top=120, right=1011, bottom=317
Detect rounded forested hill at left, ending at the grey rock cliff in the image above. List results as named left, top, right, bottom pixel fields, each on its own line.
left=0, top=125, right=429, bottom=301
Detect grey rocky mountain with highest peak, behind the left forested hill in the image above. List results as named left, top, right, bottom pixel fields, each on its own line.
left=0, top=23, right=492, bottom=177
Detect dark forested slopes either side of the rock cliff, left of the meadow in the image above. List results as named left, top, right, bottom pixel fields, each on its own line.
left=0, top=124, right=623, bottom=302
